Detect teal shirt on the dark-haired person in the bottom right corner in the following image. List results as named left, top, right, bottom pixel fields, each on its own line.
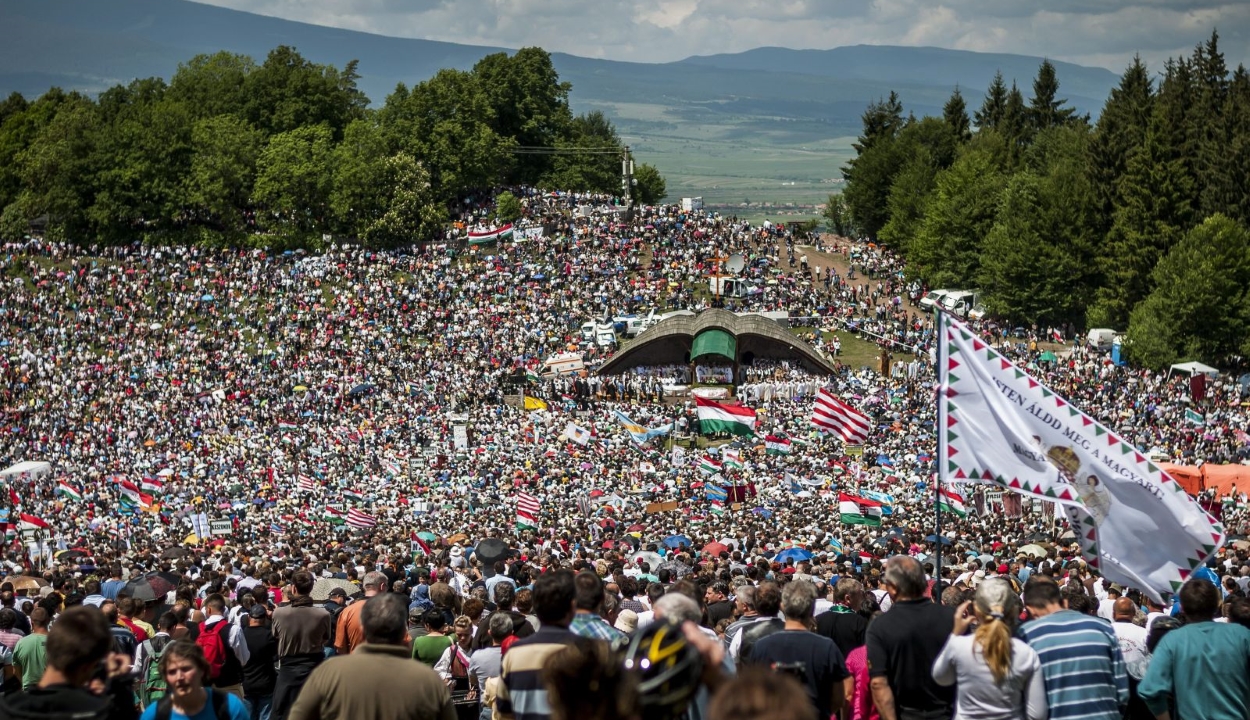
left=1138, top=623, right=1250, bottom=720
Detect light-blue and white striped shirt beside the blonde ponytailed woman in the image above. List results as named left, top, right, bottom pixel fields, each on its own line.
left=1020, top=610, right=1129, bottom=720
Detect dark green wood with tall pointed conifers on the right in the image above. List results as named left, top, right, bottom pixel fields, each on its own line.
left=826, top=33, right=1250, bottom=368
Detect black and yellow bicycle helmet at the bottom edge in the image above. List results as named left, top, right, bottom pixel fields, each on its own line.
left=621, top=620, right=703, bottom=720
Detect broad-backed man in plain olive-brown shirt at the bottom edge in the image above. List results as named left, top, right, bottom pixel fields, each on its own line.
left=290, top=593, right=456, bottom=720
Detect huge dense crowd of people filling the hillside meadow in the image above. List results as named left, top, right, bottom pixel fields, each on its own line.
left=0, top=190, right=1250, bottom=720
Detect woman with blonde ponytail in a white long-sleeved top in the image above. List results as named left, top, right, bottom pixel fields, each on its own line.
left=933, top=578, right=1046, bottom=720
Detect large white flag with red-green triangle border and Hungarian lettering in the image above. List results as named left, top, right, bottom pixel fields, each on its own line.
left=938, top=314, right=1225, bottom=601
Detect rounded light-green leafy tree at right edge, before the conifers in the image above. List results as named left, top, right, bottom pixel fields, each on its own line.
left=1125, top=215, right=1250, bottom=370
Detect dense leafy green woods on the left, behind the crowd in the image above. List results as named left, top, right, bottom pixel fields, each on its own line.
left=0, top=46, right=665, bottom=248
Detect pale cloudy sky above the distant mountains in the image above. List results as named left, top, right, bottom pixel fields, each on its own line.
left=187, top=0, right=1250, bottom=73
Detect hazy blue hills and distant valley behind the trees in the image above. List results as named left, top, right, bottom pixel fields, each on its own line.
left=0, top=0, right=1116, bottom=210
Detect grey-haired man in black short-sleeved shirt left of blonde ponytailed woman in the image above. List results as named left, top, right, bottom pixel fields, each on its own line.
left=865, top=555, right=955, bottom=720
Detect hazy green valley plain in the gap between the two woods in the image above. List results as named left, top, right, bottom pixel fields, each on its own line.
left=577, top=103, right=854, bottom=213
